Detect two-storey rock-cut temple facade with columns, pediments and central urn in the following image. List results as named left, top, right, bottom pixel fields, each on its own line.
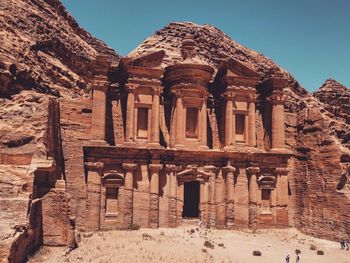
left=80, top=35, right=290, bottom=230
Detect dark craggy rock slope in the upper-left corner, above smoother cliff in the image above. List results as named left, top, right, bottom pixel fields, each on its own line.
left=0, top=0, right=118, bottom=97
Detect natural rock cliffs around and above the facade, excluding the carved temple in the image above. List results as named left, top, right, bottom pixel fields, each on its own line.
left=0, top=0, right=350, bottom=262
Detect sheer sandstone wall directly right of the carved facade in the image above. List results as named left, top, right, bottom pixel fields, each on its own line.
left=290, top=95, right=350, bottom=240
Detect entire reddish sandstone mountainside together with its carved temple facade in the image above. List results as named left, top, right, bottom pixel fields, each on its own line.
left=0, top=0, right=350, bottom=262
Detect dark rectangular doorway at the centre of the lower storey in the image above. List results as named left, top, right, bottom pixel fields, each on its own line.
left=182, top=181, right=199, bottom=218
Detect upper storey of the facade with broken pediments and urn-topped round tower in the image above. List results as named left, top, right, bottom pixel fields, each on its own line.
left=92, top=35, right=288, bottom=152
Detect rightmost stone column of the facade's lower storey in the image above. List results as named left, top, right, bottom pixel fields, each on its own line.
left=276, top=167, right=289, bottom=227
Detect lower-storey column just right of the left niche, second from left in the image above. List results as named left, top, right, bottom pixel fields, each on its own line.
left=122, top=163, right=137, bottom=227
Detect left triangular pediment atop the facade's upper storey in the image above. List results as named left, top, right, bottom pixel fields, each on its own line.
left=123, top=50, right=165, bottom=68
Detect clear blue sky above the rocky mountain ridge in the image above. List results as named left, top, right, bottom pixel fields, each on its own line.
left=62, top=0, right=350, bottom=91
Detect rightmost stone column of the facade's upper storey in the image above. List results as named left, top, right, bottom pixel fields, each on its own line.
left=270, top=91, right=285, bottom=150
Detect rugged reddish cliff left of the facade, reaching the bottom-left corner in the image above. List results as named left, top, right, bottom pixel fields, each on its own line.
left=0, top=0, right=119, bottom=262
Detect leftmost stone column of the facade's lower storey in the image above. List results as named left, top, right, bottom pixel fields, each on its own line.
left=85, top=162, right=103, bottom=230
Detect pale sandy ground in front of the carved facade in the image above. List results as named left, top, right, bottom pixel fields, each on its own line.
left=29, top=227, right=350, bottom=263
